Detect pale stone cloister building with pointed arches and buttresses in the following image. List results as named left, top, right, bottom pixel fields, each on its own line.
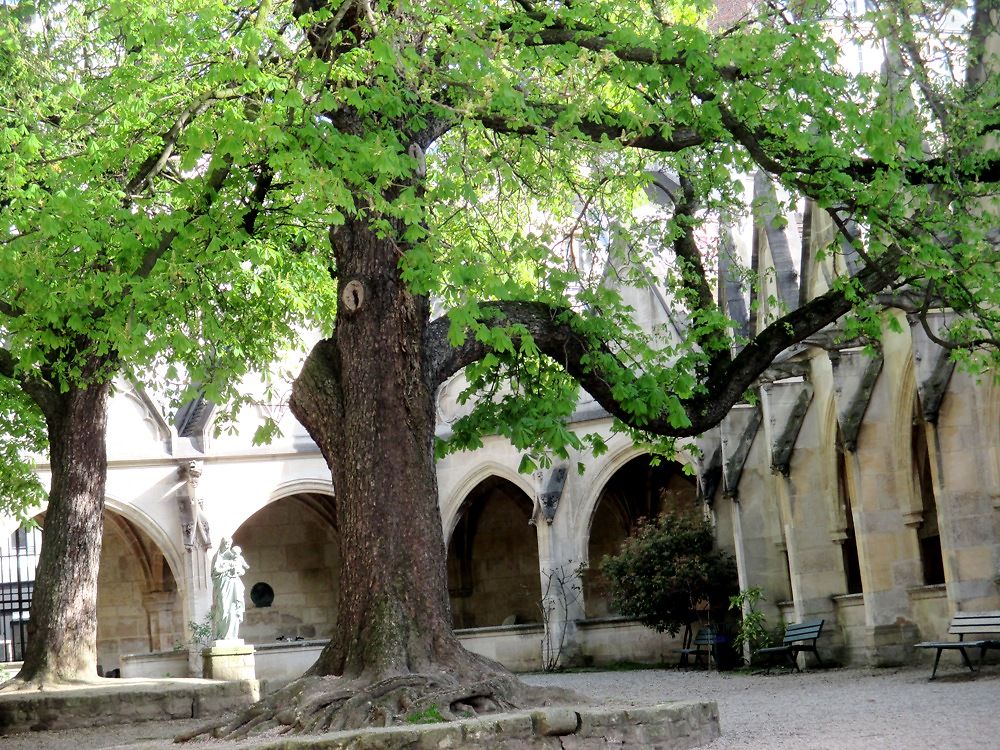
left=0, top=173, right=1000, bottom=678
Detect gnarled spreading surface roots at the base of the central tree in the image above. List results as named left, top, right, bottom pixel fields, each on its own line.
left=175, top=672, right=590, bottom=742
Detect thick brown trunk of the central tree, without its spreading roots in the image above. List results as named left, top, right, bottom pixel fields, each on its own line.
left=291, top=217, right=476, bottom=679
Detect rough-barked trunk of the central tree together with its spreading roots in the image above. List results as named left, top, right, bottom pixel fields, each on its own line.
left=187, top=219, right=585, bottom=739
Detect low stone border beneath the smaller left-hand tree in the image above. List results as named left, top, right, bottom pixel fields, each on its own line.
left=0, top=679, right=260, bottom=745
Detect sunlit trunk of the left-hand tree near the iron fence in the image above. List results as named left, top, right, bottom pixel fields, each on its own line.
left=18, top=383, right=110, bottom=684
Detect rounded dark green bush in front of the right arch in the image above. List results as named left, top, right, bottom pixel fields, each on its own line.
left=601, top=513, right=737, bottom=635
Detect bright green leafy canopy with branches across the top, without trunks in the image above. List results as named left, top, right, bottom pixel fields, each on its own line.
left=0, top=0, right=998, bottom=476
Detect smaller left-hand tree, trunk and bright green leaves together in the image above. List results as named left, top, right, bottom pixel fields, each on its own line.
left=0, top=3, right=336, bottom=689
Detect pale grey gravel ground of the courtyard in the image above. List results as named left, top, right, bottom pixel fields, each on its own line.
left=0, top=664, right=1000, bottom=750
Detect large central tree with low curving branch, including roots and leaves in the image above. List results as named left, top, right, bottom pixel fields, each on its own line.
left=5, top=0, right=1000, bottom=733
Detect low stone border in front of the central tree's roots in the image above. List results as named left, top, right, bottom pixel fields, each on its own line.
left=241, top=701, right=719, bottom=750
